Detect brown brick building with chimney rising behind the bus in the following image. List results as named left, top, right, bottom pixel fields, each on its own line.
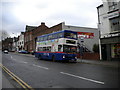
left=24, top=22, right=62, bottom=52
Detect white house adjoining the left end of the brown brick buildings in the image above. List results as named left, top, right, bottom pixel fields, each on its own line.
left=17, top=32, right=24, bottom=51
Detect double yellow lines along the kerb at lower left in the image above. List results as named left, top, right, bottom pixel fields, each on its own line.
left=0, top=63, right=34, bottom=90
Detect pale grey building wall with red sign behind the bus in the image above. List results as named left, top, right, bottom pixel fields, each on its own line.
left=62, top=22, right=99, bottom=52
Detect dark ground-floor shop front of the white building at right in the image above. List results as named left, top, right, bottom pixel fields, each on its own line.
left=100, top=36, right=120, bottom=60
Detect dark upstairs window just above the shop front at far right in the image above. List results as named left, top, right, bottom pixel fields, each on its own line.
left=110, top=17, right=120, bottom=32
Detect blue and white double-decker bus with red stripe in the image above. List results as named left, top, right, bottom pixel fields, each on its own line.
left=35, top=30, right=77, bottom=61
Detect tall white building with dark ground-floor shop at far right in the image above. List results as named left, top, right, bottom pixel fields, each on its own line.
left=97, top=0, right=120, bottom=60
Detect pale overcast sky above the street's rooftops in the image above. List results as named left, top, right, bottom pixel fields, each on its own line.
left=0, top=0, right=102, bottom=36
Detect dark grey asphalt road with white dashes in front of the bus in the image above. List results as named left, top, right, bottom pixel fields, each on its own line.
left=2, top=53, right=119, bottom=88
